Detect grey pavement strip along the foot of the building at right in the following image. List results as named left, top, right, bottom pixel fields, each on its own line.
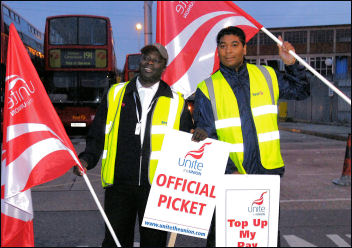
left=278, top=121, right=351, bottom=141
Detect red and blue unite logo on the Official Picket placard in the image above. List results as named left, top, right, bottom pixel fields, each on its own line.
left=178, top=142, right=211, bottom=176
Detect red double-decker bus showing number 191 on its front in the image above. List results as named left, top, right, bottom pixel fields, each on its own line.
left=44, top=15, right=117, bottom=131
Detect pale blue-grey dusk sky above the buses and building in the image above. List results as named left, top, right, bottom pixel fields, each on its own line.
left=4, top=1, right=351, bottom=69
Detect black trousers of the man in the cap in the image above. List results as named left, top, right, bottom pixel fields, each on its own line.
left=102, top=185, right=167, bottom=247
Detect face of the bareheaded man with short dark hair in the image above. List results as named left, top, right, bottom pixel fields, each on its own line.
left=218, top=34, right=247, bottom=70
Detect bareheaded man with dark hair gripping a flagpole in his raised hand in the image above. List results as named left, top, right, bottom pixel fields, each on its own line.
left=193, top=27, right=310, bottom=246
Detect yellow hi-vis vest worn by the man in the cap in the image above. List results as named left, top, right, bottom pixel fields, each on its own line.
left=101, top=82, right=184, bottom=187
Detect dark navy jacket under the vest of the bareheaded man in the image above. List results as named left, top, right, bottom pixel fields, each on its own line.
left=193, top=61, right=310, bottom=175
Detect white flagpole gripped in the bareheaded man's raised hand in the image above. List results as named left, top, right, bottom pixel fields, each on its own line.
left=261, top=27, right=351, bottom=105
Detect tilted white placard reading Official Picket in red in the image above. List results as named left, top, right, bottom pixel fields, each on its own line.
left=142, top=129, right=229, bottom=239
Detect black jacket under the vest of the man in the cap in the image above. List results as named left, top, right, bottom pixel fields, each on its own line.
left=79, top=78, right=194, bottom=185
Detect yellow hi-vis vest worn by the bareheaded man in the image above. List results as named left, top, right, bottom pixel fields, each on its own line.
left=198, top=64, right=284, bottom=174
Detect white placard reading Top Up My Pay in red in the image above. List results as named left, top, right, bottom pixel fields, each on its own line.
left=216, top=175, right=280, bottom=247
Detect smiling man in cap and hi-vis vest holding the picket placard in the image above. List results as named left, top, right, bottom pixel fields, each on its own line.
left=74, top=43, right=206, bottom=247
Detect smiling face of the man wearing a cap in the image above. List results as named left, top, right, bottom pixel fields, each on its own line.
left=139, top=50, right=165, bottom=83
